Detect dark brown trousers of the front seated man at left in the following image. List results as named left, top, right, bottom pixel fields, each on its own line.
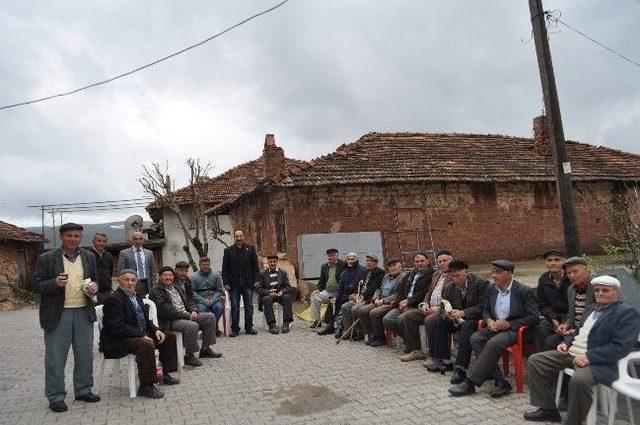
left=127, top=332, right=178, bottom=387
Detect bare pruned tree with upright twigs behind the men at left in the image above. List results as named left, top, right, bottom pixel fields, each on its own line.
left=138, top=158, right=211, bottom=271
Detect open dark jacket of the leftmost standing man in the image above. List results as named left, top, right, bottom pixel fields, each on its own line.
left=32, top=248, right=98, bottom=329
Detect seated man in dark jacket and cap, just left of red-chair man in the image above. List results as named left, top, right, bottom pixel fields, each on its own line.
left=427, top=260, right=489, bottom=384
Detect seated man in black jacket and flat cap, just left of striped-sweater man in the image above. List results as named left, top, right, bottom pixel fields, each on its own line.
left=536, top=249, right=571, bottom=351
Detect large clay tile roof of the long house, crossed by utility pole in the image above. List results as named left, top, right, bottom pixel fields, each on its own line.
left=281, top=133, right=640, bottom=186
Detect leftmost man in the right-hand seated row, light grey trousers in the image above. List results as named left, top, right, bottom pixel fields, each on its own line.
left=310, top=248, right=347, bottom=334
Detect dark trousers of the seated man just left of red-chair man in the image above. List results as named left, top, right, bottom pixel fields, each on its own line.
left=433, top=316, right=478, bottom=372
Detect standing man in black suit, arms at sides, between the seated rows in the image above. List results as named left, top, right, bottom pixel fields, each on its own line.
left=222, top=230, right=260, bottom=337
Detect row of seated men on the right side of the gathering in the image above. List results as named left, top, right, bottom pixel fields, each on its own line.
left=311, top=249, right=640, bottom=424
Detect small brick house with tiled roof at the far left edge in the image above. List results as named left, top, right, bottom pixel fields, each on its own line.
left=0, top=221, right=43, bottom=289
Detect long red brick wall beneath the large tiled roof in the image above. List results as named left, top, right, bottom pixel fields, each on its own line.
left=225, top=182, right=612, bottom=264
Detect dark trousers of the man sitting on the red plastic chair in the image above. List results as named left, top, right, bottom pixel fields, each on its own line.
left=469, top=328, right=518, bottom=386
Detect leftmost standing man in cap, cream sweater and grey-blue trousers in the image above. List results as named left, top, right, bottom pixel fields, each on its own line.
left=33, top=223, right=100, bottom=412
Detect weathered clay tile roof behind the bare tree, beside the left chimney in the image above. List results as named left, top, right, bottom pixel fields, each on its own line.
left=146, top=157, right=305, bottom=221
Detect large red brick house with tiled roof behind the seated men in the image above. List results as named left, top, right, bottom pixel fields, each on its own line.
left=208, top=117, right=640, bottom=272
